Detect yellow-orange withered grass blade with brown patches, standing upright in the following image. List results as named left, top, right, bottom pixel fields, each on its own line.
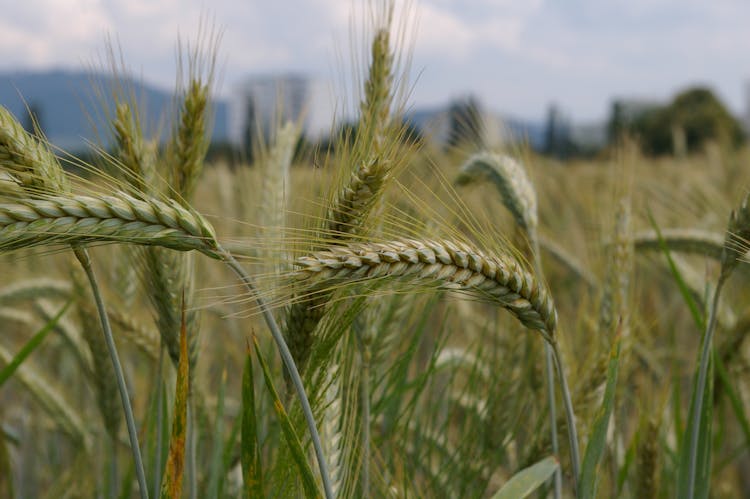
left=160, top=307, right=190, bottom=499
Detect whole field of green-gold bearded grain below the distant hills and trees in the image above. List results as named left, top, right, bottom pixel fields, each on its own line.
left=0, top=4, right=750, bottom=498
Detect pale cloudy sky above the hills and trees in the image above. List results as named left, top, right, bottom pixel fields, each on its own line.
left=0, top=0, right=750, bottom=122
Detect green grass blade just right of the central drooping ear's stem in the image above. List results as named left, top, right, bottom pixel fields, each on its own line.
left=578, top=328, right=622, bottom=499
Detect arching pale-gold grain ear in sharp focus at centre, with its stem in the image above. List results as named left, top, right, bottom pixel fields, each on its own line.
left=292, top=239, right=579, bottom=488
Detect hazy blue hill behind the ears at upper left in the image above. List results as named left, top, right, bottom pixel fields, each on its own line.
left=0, top=70, right=228, bottom=152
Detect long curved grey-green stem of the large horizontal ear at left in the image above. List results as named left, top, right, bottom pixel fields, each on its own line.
left=218, top=248, right=334, bottom=499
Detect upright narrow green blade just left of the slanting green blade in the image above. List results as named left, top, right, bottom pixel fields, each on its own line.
left=240, top=345, right=263, bottom=498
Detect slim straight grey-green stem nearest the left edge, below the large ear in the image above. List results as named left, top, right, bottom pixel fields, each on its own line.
left=73, top=247, right=148, bottom=499
